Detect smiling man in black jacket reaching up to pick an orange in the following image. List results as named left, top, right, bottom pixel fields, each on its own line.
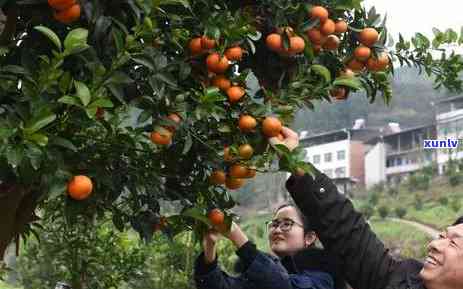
left=271, top=128, right=463, bottom=289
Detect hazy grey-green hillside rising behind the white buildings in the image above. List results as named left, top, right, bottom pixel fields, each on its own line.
left=293, top=68, right=458, bottom=133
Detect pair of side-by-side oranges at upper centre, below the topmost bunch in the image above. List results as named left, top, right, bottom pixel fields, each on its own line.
left=265, top=27, right=305, bottom=56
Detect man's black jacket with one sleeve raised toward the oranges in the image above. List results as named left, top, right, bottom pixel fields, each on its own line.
left=286, top=171, right=425, bottom=289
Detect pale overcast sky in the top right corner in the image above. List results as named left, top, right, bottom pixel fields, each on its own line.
left=363, top=0, right=463, bottom=41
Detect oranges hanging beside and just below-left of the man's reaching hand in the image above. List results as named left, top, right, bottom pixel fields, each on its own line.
left=209, top=114, right=283, bottom=190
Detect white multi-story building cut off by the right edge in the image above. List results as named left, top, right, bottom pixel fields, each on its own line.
left=435, top=96, right=463, bottom=174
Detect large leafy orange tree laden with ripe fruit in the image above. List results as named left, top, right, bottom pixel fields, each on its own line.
left=0, top=0, right=462, bottom=254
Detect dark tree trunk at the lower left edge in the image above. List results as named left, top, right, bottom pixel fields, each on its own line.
left=0, top=184, right=37, bottom=259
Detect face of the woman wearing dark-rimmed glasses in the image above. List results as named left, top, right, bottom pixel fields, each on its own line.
left=268, top=206, right=314, bottom=257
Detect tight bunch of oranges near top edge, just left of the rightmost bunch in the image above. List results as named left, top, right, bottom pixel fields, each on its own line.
left=307, top=6, right=347, bottom=53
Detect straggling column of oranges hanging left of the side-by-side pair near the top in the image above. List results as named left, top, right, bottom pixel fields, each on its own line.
left=188, top=36, right=246, bottom=104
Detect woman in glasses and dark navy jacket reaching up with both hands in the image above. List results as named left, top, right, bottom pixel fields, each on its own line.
left=195, top=205, right=344, bottom=289
